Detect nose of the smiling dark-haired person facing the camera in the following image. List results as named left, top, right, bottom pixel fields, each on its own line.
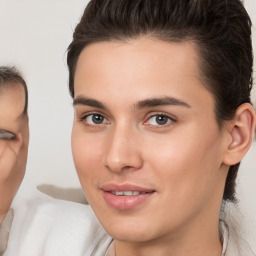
left=105, top=127, right=143, bottom=173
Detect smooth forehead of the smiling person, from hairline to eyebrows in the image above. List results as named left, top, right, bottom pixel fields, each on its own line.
left=74, top=38, right=212, bottom=104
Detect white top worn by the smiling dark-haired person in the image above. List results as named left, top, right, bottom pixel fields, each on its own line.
left=0, top=193, right=254, bottom=256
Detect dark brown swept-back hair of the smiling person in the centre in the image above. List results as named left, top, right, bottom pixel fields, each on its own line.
left=67, top=0, right=253, bottom=201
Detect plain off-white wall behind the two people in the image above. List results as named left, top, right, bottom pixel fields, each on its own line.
left=0, top=0, right=256, bottom=250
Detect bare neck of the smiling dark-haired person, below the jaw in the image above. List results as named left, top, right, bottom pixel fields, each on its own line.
left=114, top=220, right=222, bottom=256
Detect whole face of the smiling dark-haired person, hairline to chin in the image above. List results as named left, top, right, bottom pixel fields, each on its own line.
left=72, top=38, right=228, bottom=242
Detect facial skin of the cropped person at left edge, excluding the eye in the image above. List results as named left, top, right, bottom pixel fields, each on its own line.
left=0, top=84, right=29, bottom=223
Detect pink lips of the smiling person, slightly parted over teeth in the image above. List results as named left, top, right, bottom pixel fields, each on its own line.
left=101, top=184, right=155, bottom=210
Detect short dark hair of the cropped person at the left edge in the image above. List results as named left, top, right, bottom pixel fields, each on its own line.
left=0, top=66, right=28, bottom=114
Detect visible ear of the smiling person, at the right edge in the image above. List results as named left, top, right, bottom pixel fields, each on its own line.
left=223, top=103, right=256, bottom=166
